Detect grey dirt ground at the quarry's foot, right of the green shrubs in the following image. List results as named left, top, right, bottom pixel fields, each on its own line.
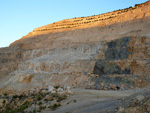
left=44, top=89, right=150, bottom=113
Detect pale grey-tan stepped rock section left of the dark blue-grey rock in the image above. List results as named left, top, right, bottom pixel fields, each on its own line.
left=2, top=42, right=107, bottom=89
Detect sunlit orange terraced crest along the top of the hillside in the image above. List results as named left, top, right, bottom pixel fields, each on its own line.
left=19, top=1, right=150, bottom=38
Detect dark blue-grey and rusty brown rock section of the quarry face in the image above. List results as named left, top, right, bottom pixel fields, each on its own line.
left=94, top=37, right=150, bottom=87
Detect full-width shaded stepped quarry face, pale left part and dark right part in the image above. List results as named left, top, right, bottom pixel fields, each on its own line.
left=0, top=37, right=150, bottom=90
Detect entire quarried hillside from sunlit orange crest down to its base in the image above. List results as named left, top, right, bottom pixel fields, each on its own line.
left=0, top=2, right=150, bottom=90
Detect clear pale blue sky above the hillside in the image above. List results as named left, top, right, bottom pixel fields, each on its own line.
left=0, top=0, right=148, bottom=47
